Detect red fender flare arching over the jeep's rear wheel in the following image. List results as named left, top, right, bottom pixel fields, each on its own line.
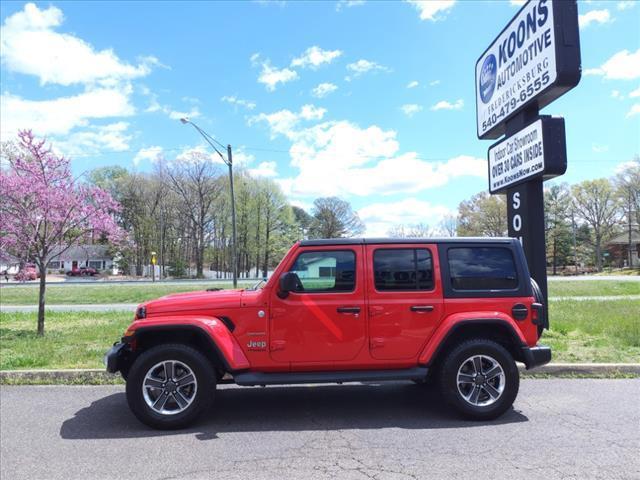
left=418, top=312, right=527, bottom=365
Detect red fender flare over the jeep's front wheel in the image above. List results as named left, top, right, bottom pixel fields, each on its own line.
left=129, top=315, right=251, bottom=372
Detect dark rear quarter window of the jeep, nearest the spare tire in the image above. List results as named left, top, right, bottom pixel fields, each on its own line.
left=448, top=247, right=518, bottom=290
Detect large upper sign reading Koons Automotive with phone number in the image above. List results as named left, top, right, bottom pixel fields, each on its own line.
left=475, top=0, right=580, bottom=139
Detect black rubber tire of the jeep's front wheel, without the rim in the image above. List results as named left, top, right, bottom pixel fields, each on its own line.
left=126, top=344, right=216, bottom=430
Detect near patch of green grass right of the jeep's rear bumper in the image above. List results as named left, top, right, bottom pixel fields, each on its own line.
left=541, top=299, right=640, bottom=363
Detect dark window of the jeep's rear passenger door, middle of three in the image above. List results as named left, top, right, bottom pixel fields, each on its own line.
left=373, top=248, right=433, bottom=291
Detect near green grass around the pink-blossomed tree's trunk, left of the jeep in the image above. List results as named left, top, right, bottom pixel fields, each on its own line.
left=0, top=311, right=133, bottom=370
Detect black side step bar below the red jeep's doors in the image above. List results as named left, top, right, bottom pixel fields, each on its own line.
left=233, top=367, right=429, bottom=387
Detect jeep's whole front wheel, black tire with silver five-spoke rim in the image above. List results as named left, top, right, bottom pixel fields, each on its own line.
left=126, top=344, right=216, bottom=429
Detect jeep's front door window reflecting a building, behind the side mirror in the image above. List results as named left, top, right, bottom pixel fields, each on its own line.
left=289, top=250, right=356, bottom=292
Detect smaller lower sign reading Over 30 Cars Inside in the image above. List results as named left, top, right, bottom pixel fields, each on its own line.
left=487, top=116, right=567, bottom=193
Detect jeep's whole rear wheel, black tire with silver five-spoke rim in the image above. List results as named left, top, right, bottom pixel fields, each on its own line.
left=440, top=339, right=520, bottom=420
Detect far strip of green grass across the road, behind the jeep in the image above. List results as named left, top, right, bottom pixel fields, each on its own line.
left=0, top=280, right=640, bottom=305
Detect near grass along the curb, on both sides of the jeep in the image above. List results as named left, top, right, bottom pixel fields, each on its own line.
left=0, top=299, right=640, bottom=370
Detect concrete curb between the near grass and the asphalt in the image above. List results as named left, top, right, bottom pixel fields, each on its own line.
left=0, top=363, right=640, bottom=385
